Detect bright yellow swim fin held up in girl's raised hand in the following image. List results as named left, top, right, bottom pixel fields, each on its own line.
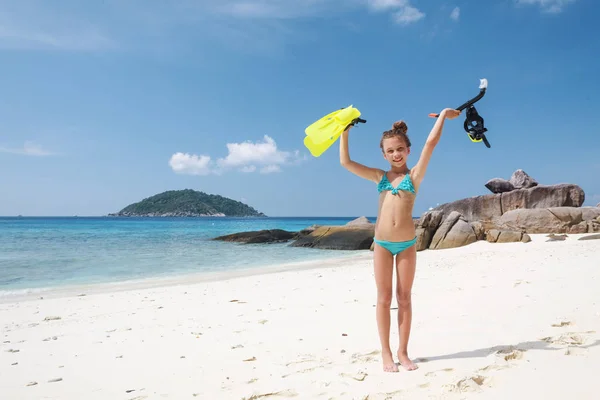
left=304, top=105, right=367, bottom=157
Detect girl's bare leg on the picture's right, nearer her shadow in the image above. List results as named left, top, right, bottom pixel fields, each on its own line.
left=396, top=246, right=417, bottom=371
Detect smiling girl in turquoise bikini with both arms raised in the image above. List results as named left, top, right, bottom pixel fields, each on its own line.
left=340, top=108, right=460, bottom=372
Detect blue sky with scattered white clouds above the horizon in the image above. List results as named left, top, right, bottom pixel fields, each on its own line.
left=0, top=0, right=600, bottom=216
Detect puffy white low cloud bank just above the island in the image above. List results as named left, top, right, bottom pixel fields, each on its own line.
left=169, top=135, right=302, bottom=175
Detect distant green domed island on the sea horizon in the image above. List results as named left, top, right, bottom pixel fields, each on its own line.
left=108, top=189, right=266, bottom=217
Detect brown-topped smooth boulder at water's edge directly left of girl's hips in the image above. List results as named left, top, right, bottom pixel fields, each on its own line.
left=290, top=224, right=375, bottom=250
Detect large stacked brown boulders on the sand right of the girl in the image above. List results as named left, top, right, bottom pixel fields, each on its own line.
left=416, top=170, right=600, bottom=251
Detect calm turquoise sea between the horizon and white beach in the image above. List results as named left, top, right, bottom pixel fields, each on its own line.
left=0, top=217, right=374, bottom=296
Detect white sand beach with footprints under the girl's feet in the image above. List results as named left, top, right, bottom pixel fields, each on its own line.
left=0, top=235, right=600, bottom=400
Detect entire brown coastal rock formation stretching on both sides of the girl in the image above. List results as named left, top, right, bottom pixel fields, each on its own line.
left=211, top=170, right=600, bottom=251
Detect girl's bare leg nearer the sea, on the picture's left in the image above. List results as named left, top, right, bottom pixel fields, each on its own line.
left=373, top=244, right=398, bottom=372
